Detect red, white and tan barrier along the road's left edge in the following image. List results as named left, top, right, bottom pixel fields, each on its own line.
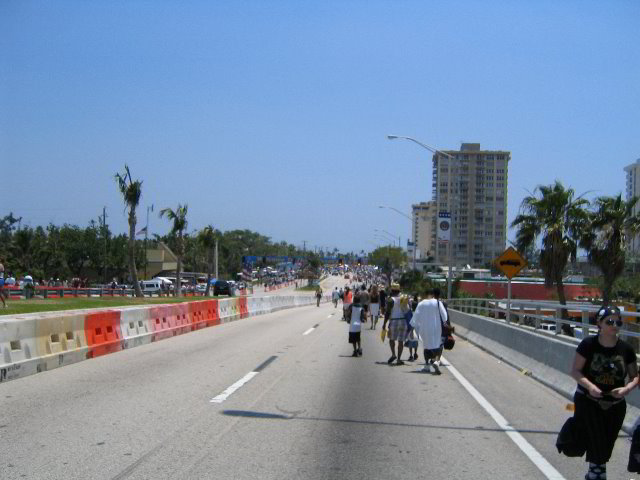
left=0, top=295, right=326, bottom=382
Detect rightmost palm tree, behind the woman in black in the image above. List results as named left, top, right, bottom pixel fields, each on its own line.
left=580, top=194, right=640, bottom=305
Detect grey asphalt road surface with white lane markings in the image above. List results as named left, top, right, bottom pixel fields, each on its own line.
left=0, top=296, right=633, bottom=480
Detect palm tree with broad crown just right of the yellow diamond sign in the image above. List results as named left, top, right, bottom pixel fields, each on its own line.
left=511, top=180, right=589, bottom=318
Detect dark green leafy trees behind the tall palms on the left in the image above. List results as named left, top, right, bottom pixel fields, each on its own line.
left=0, top=213, right=309, bottom=283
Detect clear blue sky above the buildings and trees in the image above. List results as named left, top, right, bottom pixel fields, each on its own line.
left=0, top=0, right=640, bottom=253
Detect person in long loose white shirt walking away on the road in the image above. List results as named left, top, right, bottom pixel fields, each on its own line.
left=411, top=288, right=448, bottom=375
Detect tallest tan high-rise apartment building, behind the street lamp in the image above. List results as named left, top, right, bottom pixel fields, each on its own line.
left=432, top=143, right=511, bottom=267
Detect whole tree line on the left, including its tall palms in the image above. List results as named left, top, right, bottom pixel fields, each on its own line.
left=0, top=164, right=355, bottom=296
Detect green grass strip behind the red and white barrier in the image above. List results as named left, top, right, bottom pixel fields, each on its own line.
left=0, top=297, right=228, bottom=315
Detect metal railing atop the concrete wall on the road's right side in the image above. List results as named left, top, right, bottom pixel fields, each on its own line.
left=448, top=298, right=640, bottom=344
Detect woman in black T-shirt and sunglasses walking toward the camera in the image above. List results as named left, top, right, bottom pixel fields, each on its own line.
left=571, top=305, right=638, bottom=480
